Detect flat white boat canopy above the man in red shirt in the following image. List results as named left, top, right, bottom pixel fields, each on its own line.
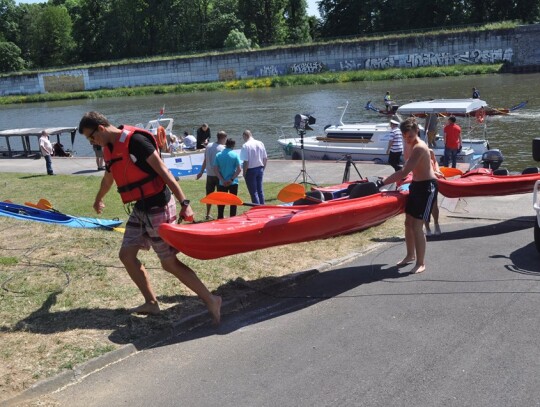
left=397, top=99, right=487, bottom=115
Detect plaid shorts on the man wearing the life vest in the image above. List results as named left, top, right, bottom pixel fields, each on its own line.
left=122, top=196, right=178, bottom=260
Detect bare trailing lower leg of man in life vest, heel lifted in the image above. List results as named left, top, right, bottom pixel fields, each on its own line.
left=161, top=256, right=222, bottom=325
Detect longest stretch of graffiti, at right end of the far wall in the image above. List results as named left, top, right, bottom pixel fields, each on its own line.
left=364, top=48, right=513, bottom=69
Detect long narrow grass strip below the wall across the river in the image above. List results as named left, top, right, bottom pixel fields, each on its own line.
left=0, top=64, right=502, bottom=105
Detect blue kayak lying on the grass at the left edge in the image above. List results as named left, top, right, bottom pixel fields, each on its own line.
left=0, top=202, right=122, bottom=230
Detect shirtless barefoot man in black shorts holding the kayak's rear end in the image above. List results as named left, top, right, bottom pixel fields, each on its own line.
left=382, top=118, right=438, bottom=274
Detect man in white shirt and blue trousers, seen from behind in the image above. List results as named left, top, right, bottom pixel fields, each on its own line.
left=240, top=130, right=268, bottom=205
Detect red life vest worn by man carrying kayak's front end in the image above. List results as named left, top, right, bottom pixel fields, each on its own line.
left=103, top=125, right=165, bottom=203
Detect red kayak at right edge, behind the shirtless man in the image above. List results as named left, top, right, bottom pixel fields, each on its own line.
left=438, top=168, right=540, bottom=198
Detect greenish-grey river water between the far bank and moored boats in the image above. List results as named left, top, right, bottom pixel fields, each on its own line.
left=0, top=74, right=540, bottom=171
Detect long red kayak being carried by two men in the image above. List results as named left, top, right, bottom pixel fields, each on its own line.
left=158, top=191, right=407, bottom=260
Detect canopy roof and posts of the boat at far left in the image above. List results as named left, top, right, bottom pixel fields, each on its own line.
left=0, top=127, right=77, bottom=157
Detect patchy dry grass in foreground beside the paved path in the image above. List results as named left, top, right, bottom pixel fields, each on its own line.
left=0, top=173, right=403, bottom=401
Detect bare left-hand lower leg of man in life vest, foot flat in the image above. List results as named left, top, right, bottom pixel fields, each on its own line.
left=119, top=247, right=159, bottom=315
